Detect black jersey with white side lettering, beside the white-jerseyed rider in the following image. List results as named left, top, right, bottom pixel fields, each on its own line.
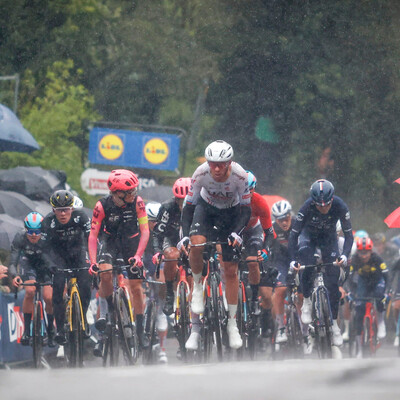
left=152, top=199, right=181, bottom=253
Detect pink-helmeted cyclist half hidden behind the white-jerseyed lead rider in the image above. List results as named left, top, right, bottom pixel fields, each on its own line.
left=152, top=178, right=191, bottom=315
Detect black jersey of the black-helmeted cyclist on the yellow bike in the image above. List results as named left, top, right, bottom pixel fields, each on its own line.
left=41, top=210, right=90, bottom=259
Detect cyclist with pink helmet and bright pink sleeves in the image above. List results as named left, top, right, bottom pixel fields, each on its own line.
left=89, top=169, right=150, bottom=347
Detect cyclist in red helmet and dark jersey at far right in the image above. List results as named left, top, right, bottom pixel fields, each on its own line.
left=350, top=237, right=389, bottom=358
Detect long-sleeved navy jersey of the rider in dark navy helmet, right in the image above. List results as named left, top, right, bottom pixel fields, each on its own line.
left=289, top=196, right=353, bottom=260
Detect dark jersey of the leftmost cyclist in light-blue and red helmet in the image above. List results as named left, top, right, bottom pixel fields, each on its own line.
left=8, top=232, right=46, bottom=276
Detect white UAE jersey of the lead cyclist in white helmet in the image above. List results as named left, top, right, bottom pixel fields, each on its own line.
left=186, top=162, right=251, bottom=209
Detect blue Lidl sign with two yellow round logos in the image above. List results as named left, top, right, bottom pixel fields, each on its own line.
left=89, top=128, right=180, bottom=170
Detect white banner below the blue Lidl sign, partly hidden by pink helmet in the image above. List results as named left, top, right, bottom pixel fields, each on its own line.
left=81, top=168, right=157, bottom=196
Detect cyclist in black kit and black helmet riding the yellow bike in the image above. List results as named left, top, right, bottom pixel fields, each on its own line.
left=41, top=190, right=91, bottom=345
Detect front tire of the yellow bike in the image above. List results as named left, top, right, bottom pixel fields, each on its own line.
left=69, top=292, right=83, bottom=367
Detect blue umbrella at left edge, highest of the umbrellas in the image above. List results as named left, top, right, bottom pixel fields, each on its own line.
left=0, top=104, right=40, bottom=153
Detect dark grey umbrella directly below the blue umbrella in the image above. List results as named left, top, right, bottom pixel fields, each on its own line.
left=0, top=167, right=67, bottom=201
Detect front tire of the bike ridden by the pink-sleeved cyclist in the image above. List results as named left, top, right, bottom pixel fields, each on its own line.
left=116, top=288, right=139, bottom=365
